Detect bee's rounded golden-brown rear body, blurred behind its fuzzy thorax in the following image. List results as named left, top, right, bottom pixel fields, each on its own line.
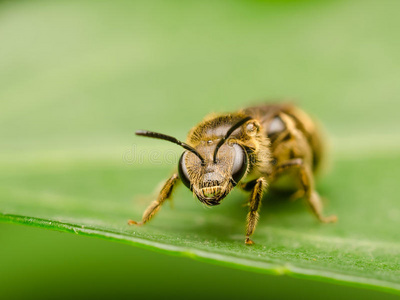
left=244, top=104, right=323, bottom=190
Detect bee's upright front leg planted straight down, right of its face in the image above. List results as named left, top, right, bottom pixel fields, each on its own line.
left=244, top=177, right=267, bottom=245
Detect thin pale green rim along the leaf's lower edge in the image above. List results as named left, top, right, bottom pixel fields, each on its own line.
left=0, top=213, right=400, bottom=295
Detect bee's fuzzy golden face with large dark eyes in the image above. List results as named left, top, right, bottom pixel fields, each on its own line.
left=178, top=140, right=248, bottom=206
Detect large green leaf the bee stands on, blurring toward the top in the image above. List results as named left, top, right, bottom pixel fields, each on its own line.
left=0, top=1, right=400, bottom=293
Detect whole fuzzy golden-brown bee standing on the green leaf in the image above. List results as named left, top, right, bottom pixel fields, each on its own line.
left=128, top=104, right=337, bottom=245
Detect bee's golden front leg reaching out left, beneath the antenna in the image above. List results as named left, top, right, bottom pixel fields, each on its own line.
left=128, top=174, right=179, bottom=226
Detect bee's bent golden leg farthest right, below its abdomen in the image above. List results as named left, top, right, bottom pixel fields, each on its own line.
left=272, top=158, right=337, bottom=223
